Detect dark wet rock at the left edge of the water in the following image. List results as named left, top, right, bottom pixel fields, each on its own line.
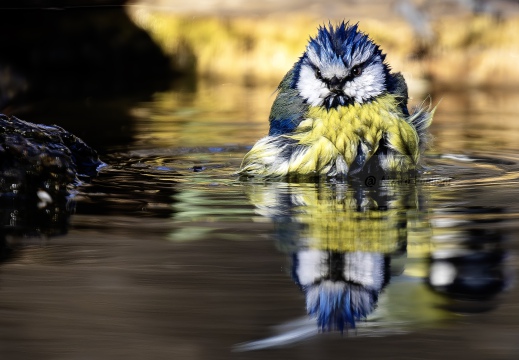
left=0, top=114, right=103, bottom=249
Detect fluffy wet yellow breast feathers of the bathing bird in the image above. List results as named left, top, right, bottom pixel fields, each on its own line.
left=242, top=94, right=420, bottom=176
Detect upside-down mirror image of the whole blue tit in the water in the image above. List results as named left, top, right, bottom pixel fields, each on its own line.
left=244, top=183, right=420, bottom=331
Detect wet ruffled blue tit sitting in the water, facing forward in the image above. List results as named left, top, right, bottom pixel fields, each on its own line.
left=240, top=22, right=434, bottom=177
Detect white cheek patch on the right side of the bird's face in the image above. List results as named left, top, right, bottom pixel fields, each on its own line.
left=344, top=63, right=386, bottom=104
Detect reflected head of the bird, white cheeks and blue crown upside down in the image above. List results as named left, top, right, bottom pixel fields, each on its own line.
left=293, top=250, right=389, bottom=332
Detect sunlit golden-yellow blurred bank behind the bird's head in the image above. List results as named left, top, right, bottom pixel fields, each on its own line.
left=128, top=0, right=518, bottom=87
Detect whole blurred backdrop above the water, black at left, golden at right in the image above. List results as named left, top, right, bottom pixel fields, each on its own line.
left=0, top=0, right=519, bottom=93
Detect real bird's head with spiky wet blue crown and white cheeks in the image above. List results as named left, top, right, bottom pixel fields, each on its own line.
left=291, top=22, right=389, bottom=110
